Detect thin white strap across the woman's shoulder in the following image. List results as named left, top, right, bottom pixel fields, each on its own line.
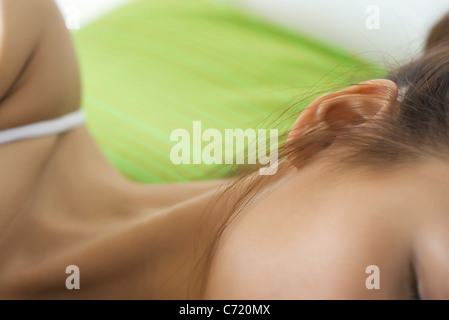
left=0, top=110, right=85, bottom=145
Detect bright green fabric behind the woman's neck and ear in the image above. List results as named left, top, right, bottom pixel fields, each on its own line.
left=75, top=0, right=380, bottom=183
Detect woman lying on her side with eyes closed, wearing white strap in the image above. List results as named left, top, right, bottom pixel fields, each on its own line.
left=0, top=0, right=449, bottom=299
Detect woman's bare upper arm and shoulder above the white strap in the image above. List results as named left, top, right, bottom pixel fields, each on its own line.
left=0, top=0, right=81, bottom=130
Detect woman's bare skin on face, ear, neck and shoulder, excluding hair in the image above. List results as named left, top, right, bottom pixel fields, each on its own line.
left=0, top=0, right=449, bottom=299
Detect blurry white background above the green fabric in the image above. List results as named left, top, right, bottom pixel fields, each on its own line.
left=56, top=0, right=449, bottom=63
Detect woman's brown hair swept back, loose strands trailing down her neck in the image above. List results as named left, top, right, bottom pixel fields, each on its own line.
left=192, top=14, right=449, bottom=297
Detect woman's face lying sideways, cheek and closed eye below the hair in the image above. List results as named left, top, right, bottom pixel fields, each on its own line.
left=206, top=156, right=449, bottom=299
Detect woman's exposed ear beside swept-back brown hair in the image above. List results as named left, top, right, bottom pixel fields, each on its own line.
left=287, top=79, right=398, bottom=168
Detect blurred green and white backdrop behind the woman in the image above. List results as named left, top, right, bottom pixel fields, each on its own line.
left=52, top=0, right=449, bottom=183
